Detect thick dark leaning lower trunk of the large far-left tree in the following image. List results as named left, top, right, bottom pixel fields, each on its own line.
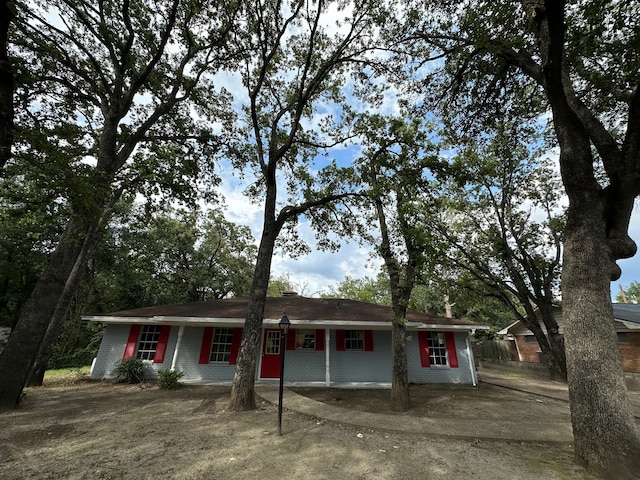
left=0, top=218, right=96, bottom=409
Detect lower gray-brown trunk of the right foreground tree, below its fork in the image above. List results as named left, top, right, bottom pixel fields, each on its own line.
left=562, top=202, right=640, bottom=479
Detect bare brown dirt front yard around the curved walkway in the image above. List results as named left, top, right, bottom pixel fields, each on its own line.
left=0, top=381, right=594, bottom=480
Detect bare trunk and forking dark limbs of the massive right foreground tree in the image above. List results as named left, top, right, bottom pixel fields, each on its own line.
left=525, top=1, right=640, bottom=472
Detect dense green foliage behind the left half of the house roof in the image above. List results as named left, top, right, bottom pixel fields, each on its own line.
left=93, top=202, right=256, bottom=310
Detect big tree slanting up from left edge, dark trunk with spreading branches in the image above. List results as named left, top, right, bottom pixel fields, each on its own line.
left=0, top=0, right=231, bottom=408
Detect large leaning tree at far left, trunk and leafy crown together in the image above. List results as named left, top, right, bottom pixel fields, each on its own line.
left=0, top=0, right=238, bottom=408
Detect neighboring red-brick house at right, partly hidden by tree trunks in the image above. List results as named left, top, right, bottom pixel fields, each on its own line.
left=498, top=303, right=640, bottom=373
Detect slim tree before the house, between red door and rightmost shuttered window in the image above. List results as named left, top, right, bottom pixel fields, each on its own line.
left=356, top=114, right=440, bottom=411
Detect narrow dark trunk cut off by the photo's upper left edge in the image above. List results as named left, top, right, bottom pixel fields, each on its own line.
left=0, top=0, right=16, bottom=172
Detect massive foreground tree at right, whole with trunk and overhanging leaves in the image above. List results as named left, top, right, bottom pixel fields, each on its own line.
left=407, top=0, right=640, bottom=478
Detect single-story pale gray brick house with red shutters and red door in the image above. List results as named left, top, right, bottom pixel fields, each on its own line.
left=84, top=294, right=488, bottom=386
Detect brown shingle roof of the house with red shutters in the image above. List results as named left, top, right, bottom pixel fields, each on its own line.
left=91, top=296, right=486, bottom=329
